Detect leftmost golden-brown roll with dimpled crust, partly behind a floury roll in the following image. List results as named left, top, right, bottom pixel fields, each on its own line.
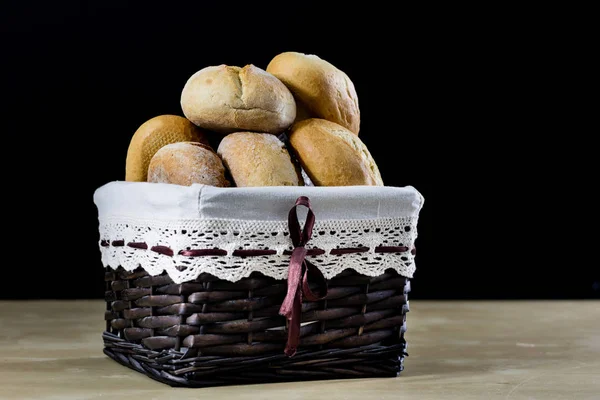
left=125, top=115, right=208, bottom=182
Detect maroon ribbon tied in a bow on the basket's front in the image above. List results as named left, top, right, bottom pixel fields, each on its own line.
left=279, top=196, right=327, bottom=357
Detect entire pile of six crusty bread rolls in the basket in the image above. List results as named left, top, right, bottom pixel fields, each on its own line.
left=125, top=52, right=383, bottom=187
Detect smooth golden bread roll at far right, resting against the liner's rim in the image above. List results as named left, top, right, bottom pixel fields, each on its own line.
left=289, top=118, right=383, bottom=186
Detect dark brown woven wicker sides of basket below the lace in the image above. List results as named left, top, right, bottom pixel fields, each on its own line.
left=103, top=267, right=410, bottom=387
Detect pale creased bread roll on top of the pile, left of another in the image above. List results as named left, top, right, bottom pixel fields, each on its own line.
left=181, top=65, right=296, bottom=134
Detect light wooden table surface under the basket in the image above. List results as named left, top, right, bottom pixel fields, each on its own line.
left=0, top=300, right=600, bottom=400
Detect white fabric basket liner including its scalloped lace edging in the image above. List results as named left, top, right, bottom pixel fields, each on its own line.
left=94, top=181, right=424, bottom=283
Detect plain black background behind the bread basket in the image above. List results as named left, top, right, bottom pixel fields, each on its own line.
left=0, top=1, right=600, bottom=299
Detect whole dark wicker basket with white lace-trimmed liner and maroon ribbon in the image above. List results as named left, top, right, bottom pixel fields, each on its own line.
left=95, top=183, right=422, bottom=387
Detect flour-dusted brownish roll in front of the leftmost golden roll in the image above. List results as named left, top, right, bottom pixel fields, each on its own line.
left=148, top=142, right=230, bottom=187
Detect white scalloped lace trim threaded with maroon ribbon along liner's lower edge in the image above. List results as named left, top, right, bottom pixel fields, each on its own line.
left=99, top=217, right=418, bottom=283
